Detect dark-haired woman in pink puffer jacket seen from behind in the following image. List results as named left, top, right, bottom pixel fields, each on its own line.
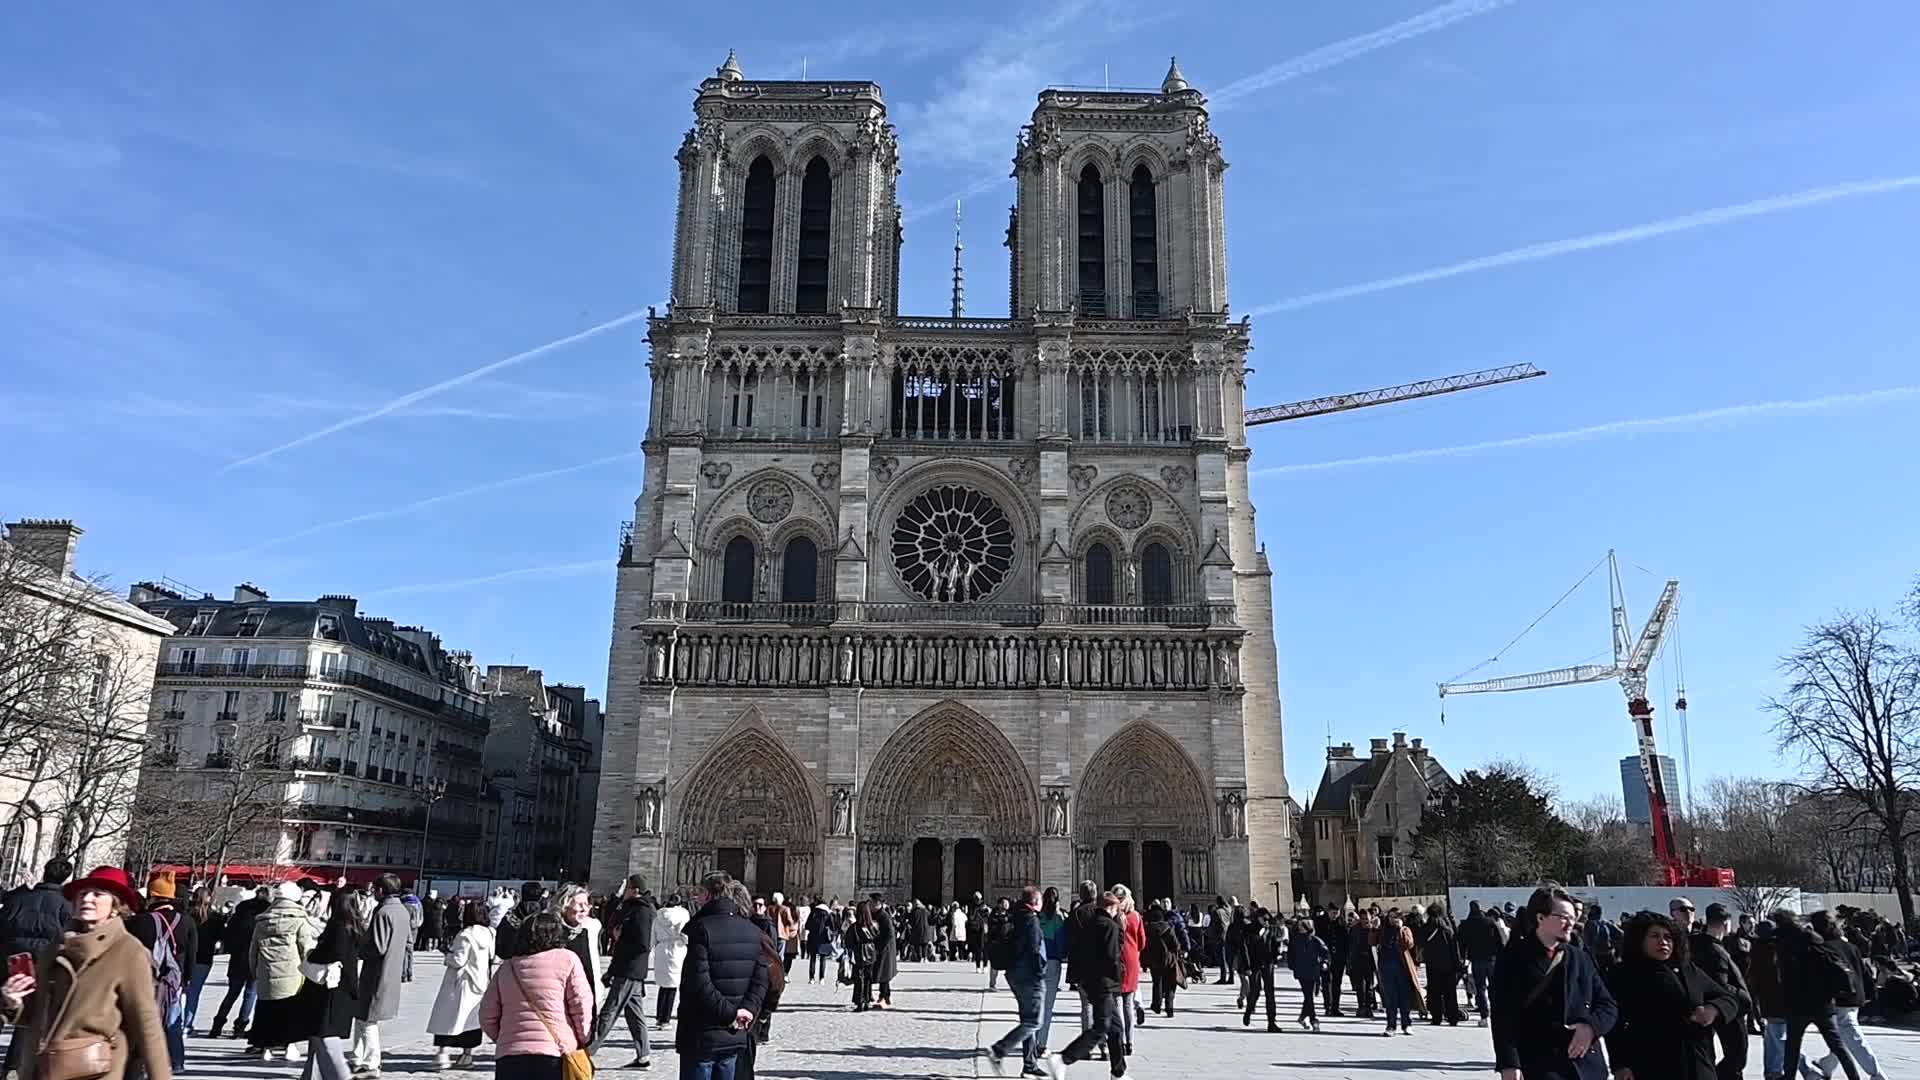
left=480, top=911, right=593, bottom=1080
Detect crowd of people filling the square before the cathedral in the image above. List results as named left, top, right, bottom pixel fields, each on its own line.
left=0, top=859, right=1907, bottom=1080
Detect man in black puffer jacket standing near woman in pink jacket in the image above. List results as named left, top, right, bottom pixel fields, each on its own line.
left=674, top=871, right=768, bottom=1080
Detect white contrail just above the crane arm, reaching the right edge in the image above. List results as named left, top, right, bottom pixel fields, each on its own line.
left=1246, top=175, right=1920, bottom=315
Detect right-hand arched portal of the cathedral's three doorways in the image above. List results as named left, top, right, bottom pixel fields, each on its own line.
left=1073, top=721, right=1213, bottom=905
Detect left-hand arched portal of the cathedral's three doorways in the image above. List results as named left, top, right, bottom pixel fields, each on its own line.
left=674, top=728, right=820, bottom=896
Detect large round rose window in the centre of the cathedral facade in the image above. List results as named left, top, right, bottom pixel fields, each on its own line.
left=893, top=484, right=1014, bottom=603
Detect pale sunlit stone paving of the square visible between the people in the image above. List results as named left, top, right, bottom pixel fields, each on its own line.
left=188, top=953, right=1920, bottom=1080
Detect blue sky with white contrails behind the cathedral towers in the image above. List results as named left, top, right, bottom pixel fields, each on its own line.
left=0, top=0, right=1920, bottom=798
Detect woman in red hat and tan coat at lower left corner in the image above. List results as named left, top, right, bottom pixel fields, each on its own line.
left=0, top=867, right=173, bottom=1080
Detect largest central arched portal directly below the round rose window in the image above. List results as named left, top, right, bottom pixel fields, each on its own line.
left=858, top=703, right=1041, bottom=903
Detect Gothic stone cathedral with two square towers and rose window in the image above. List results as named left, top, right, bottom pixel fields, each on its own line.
left=593, top=54, right=1290, bottom=901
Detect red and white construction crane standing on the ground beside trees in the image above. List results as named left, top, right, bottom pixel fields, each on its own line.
left=1440, top=552, right=1734, bottom=888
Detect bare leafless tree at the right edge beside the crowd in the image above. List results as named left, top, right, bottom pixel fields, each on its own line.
left=1766, top=611, right=1920, bottom=922
